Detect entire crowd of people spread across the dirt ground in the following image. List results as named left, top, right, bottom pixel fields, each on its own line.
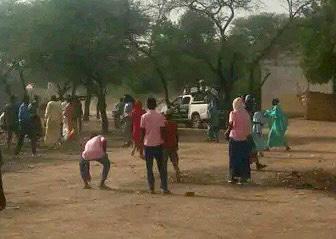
left=0, top=90, right=290, bottom=199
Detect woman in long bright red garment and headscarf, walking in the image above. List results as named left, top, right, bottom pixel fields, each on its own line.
left=131, top=100, right=146, bottom=159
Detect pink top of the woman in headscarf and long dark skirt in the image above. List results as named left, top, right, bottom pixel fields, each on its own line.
left=229, top=110, right=252, bottom=141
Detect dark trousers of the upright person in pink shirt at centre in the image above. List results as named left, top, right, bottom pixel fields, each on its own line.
left=145, top=146, right=168, bottom=191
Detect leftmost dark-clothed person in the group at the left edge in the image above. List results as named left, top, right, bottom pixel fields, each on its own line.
left=4, top=95, right=20, bottom=149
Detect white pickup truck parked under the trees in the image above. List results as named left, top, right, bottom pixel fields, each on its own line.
left=160, top=95, right=209, bottom=128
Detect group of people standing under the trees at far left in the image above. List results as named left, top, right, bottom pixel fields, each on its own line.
left=2, top=92, right=83, bottom=156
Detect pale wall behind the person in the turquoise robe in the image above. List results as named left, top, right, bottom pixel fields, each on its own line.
left=262, top=57, right=333, bottom=116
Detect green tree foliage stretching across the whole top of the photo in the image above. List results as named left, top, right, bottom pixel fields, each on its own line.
left=0, top=0, right=330, bottom=101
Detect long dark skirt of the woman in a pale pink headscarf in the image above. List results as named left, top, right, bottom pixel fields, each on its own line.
left=229, top=138, right=251, bottom=179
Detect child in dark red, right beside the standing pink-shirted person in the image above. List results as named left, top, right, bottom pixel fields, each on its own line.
left=163, top=111, right=181, bottom=182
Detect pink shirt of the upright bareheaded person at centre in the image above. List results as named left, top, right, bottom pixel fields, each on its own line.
left=140, top=110, right=166, bottom=147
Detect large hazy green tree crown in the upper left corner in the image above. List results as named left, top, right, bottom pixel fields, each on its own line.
left=0, top=0, right=143, bottom=87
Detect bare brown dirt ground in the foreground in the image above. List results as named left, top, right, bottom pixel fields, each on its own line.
left=0, top=120, right=336, bottom=239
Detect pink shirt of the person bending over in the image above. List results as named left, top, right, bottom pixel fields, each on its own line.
left=82, top=136, right=106, bottom=160
